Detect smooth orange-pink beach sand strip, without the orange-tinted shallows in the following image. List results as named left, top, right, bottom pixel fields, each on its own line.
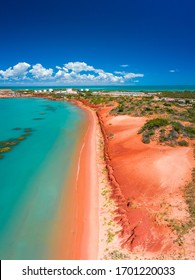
left=71, top=102, right=99, bottom=260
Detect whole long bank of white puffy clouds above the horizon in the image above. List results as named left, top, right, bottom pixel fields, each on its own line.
left=0, top=61, right=144, bottom=85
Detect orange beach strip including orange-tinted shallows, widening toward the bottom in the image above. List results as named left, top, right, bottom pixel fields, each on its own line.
left=51, top=104, right=99, bottom=260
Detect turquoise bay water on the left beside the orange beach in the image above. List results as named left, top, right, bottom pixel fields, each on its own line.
left=0, top=98, right=86, bottom=259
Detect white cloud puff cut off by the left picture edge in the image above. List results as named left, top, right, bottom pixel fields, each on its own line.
left=0, top=62, right=30, bottom=80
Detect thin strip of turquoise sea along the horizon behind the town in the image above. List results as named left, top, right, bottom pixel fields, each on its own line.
left=0, top=85, right=195, bottom=91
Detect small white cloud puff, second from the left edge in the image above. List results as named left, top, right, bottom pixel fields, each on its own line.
left=29, top=63, right=53, bottom=80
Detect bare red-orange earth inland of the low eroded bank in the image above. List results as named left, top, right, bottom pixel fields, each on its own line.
left=98, top=108, right=194, bottom=254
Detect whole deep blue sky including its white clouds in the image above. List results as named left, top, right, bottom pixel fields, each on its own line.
left=0, top=0, right=195, bottom=85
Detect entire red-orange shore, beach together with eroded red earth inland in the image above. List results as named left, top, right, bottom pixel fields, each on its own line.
left=1, top=95, right=195, bottom=260
